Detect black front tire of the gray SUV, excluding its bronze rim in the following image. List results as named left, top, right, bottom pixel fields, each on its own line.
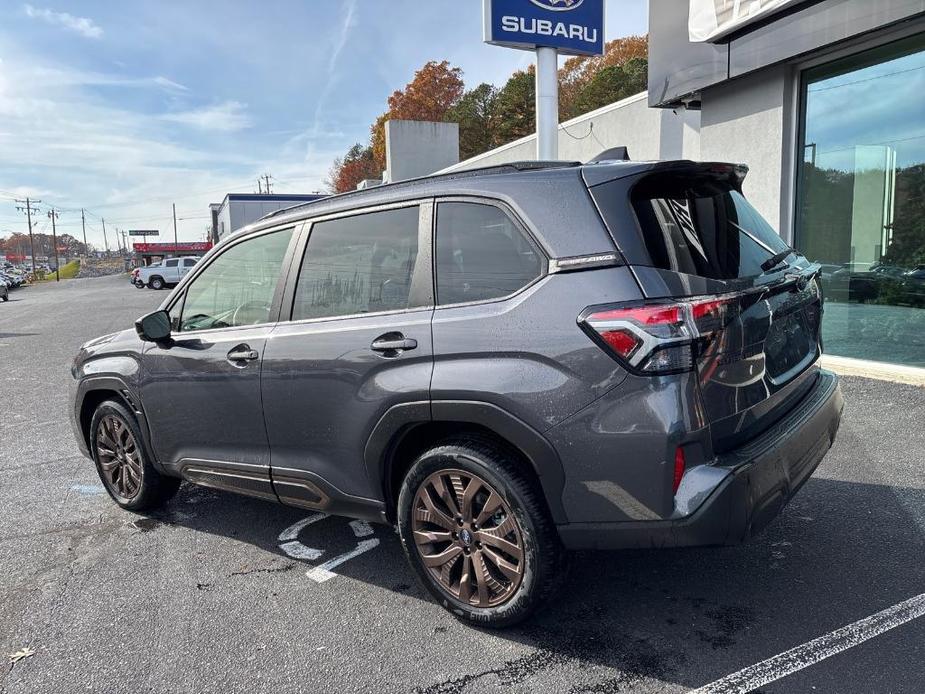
left=89, top=400, right=180, bottom=511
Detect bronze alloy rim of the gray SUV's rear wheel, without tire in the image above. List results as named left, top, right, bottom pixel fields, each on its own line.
left=411, top=470, right=525, bottom=607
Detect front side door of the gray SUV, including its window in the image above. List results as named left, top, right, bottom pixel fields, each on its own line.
left=141, top=229, right=293, bottom=498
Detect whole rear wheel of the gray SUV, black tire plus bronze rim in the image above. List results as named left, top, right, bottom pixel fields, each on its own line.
left=398, top=439, right=566, bottom=628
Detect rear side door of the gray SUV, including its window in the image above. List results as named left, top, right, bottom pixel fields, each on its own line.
left=262, top=203, right=433, bottom=508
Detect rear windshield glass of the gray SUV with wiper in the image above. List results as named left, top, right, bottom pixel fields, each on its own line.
left=632, top=175, right=788, bottom=280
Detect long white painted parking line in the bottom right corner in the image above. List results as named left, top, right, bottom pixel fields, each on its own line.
left=689, top=593, right=925, bottom=694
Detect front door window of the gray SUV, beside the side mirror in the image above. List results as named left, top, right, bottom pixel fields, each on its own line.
left=179, top=229, right=292, bottom=332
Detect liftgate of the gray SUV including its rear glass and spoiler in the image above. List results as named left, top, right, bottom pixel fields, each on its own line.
left=591, top=165, right=822, bottom=452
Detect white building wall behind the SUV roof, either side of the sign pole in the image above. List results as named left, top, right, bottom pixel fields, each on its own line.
left=443, top=92, right=700, bottom=172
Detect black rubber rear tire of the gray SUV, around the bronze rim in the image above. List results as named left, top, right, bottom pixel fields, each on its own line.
left=397, top=437, right=567, bottom=629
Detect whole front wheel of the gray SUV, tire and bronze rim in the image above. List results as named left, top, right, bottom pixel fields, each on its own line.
left=90, top=400, right=180, bottom=511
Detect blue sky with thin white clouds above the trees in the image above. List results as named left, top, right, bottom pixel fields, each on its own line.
left=0, top=0, right=648, bottom=247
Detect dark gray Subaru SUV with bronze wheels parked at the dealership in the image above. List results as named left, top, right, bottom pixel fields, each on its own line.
left=72, top=157, right=843, bottom=627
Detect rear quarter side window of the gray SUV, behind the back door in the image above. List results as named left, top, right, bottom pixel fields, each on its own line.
left=437, top=202, right=544, bottom=305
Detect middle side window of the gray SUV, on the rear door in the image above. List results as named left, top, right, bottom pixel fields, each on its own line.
left=292, top=207, right=419, bottom=320
